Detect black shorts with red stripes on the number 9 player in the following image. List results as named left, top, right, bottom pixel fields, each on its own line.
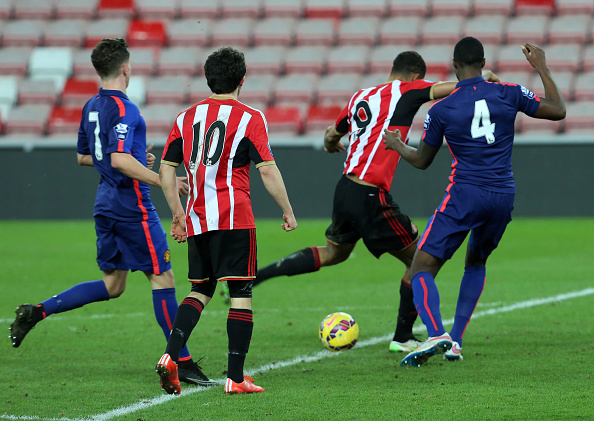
left=326, top=175, right=419, bottom=258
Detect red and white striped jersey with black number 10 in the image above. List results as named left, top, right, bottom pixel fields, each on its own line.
left=161, top=95, right=275, bottom=236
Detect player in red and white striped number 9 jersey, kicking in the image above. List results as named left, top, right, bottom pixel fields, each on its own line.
left=247, top=51, right=497, bottom=352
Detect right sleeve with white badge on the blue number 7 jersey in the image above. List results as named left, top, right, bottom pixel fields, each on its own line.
left=105, top=98, right=140, bottom=154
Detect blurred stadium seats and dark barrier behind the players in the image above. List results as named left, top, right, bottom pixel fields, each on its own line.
left=0, top=0, right=594, bottom=219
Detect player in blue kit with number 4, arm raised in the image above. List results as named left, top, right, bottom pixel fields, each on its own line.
left=383, top=37, right=565, bottom=367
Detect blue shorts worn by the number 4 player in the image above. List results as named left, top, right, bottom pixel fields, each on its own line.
left=418, top=183, right=515, bottom=259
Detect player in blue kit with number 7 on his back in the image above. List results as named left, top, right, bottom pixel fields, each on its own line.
left=10, top=38, right=211, bottom=385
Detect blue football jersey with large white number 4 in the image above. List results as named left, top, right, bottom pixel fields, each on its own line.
left=422, top=76, right=540, bottom=193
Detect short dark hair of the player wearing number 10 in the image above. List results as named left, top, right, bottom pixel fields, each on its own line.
left=204, top=47, right=246, bottom=94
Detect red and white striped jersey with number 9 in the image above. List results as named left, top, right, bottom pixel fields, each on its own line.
left=336, top=79, right=436, bottom=191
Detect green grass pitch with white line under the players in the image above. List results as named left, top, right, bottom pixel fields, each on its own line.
left=0, top=218, right=594, bottom=421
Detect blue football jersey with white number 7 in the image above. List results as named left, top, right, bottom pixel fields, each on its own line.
left=77, top=89, right=157, bottom=221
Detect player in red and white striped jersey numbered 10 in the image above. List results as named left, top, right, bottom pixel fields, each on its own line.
left=156, top=47, right=297, bottom=394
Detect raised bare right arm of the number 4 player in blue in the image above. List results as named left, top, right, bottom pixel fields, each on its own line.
left=522, top=44, right=566, bottom=120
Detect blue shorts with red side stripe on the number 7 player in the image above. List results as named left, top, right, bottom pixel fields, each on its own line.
left=95, top=215, right=171, bottom=275
